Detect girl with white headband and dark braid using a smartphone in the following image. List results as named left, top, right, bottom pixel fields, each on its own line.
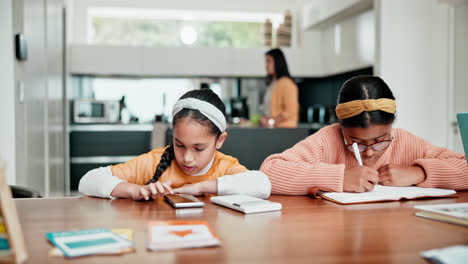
left=78, top=90, right=271, bottom=200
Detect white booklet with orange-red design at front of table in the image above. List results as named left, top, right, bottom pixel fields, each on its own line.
left=148, top=220, right=221, bottom=250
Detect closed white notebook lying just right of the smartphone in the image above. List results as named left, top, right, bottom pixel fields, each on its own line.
left=210, top=195, right=282, bottom=214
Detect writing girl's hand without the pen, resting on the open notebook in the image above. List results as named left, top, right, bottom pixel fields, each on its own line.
left=379, top=164, right=426, bottom=186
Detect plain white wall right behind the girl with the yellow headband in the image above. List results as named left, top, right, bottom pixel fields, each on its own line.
left=375, top=0, right=450, bottom=146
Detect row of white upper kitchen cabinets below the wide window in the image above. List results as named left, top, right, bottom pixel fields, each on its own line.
left=70, top=44, right=322, bottom=77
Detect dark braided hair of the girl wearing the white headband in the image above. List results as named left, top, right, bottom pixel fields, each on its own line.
left=147, top=89, right=226, bottom=184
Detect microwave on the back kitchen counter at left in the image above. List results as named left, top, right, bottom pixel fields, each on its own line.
left=72, top=99, right=120, bottom=123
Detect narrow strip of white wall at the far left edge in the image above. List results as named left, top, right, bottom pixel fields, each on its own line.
left=0, top=0, right=16, bottom=184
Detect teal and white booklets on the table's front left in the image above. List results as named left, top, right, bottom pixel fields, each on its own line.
left=46, top=228, right=134, bottom=258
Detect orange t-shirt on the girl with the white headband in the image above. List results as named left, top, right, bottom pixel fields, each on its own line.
left=111, top=148, right=247, bottom=188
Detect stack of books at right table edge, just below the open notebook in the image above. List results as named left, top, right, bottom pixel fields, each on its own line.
left=414, top=203, right=468, bottom=226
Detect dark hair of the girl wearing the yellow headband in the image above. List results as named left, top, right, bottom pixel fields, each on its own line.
left=338, top=75, right=395, bottom=128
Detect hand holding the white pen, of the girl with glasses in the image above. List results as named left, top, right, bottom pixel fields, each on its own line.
left=343, top=166, right=379, bottom=192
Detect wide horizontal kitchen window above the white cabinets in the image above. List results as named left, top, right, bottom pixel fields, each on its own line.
left=87, top=8, right=283, bottom=48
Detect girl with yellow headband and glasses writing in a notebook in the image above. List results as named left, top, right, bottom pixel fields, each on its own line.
left=260, top=76, right=468, bottom=195
